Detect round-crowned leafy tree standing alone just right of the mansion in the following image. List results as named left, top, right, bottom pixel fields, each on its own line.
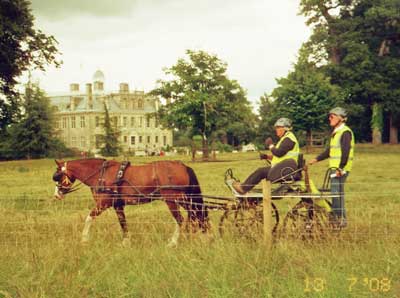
left=151, top=50, right=252, bottom=159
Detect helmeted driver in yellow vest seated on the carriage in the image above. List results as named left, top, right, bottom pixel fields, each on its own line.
left=232, top=118, right=300, bottom=194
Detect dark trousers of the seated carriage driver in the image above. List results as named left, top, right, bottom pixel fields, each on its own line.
left=242, top=159, right=297, bottom=192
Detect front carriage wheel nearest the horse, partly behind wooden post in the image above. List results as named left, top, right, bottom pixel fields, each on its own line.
left=219, top=201, right=279, bottom=240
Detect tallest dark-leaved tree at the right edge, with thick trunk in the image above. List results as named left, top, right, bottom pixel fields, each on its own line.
left=301, top=0, right=400, bottom=143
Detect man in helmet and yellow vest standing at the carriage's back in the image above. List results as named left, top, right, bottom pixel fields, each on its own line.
left=310, top=107, right=354, bottom=228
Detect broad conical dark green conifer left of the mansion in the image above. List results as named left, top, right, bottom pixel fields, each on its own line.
left=3, top=84, right=60, bottom=159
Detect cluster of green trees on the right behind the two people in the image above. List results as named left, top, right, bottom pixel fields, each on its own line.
left=260, top=0, right=400, bottom=144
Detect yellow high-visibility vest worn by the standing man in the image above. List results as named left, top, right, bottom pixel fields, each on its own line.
left=329, top=125, right=354, bottom=171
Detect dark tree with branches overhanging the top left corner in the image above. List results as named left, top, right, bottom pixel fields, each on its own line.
left=0, top=0, right=60, bottom=134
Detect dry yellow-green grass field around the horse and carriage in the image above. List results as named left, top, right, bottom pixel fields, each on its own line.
left=0, top=145, right=400, bottom=297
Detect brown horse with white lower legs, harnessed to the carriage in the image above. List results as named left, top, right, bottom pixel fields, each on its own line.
left=53, top=158, right=208, bottom=246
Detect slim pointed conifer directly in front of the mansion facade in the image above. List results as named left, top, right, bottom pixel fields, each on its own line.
left=98, top=102, right=121, bottom=156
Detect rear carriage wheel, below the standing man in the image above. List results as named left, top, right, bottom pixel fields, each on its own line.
left=282, top=201, right=331, bottom=239
